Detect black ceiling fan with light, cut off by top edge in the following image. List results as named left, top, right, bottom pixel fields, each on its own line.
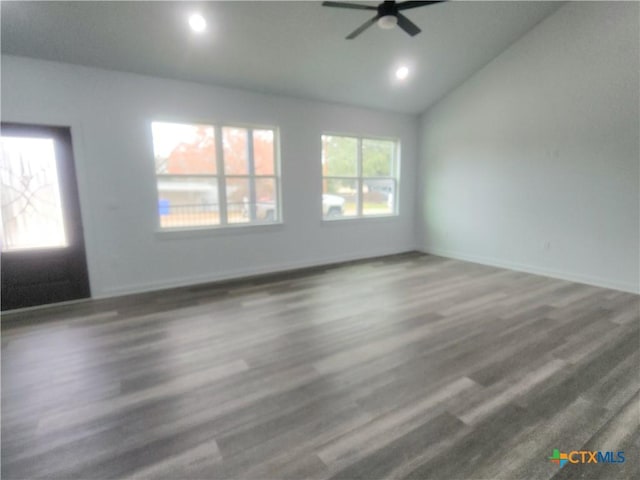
left=322, top=0, right=445, bottom=40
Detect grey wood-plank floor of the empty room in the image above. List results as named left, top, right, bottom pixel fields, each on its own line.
left=2, top=254, right=640, bottom=480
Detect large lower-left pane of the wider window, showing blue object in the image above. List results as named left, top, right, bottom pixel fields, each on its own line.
left=157, top=176, right=220, bottom=228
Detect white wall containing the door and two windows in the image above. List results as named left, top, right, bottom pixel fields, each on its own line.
left=2, top=56, right=418, bottom=297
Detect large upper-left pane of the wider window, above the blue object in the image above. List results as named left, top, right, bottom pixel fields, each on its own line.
left=151, top=122, right=216, bottom=175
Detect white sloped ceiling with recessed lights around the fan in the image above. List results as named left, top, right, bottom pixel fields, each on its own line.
left=0, top=1, right=560, bottom=113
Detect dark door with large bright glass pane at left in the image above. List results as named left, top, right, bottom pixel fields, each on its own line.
left=0, top=123, right=91, bottom=310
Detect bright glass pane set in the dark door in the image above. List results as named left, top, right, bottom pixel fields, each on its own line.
left=0, top=137, right=68, bottom=251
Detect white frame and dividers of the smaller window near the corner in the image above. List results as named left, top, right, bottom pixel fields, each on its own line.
left=320, top=132, right=401, bottom=222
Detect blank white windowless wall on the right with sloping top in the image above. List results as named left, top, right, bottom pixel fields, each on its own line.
left=417, top=2, right=640, bottom=292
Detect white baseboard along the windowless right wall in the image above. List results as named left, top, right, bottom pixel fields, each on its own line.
left=418, top=247, right=640, bottom=294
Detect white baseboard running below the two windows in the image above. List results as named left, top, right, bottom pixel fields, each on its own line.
left=92, top=247, right=416, bottom=299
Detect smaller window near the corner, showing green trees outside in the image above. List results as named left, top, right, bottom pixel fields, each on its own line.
left=322, top=135, right=399, bottom=220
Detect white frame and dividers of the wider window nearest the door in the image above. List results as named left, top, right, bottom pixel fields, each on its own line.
left=150, top=118, right=284, bottom=234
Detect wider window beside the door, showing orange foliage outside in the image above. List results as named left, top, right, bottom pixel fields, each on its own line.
left=151, top=122, right=281, bottom=229
